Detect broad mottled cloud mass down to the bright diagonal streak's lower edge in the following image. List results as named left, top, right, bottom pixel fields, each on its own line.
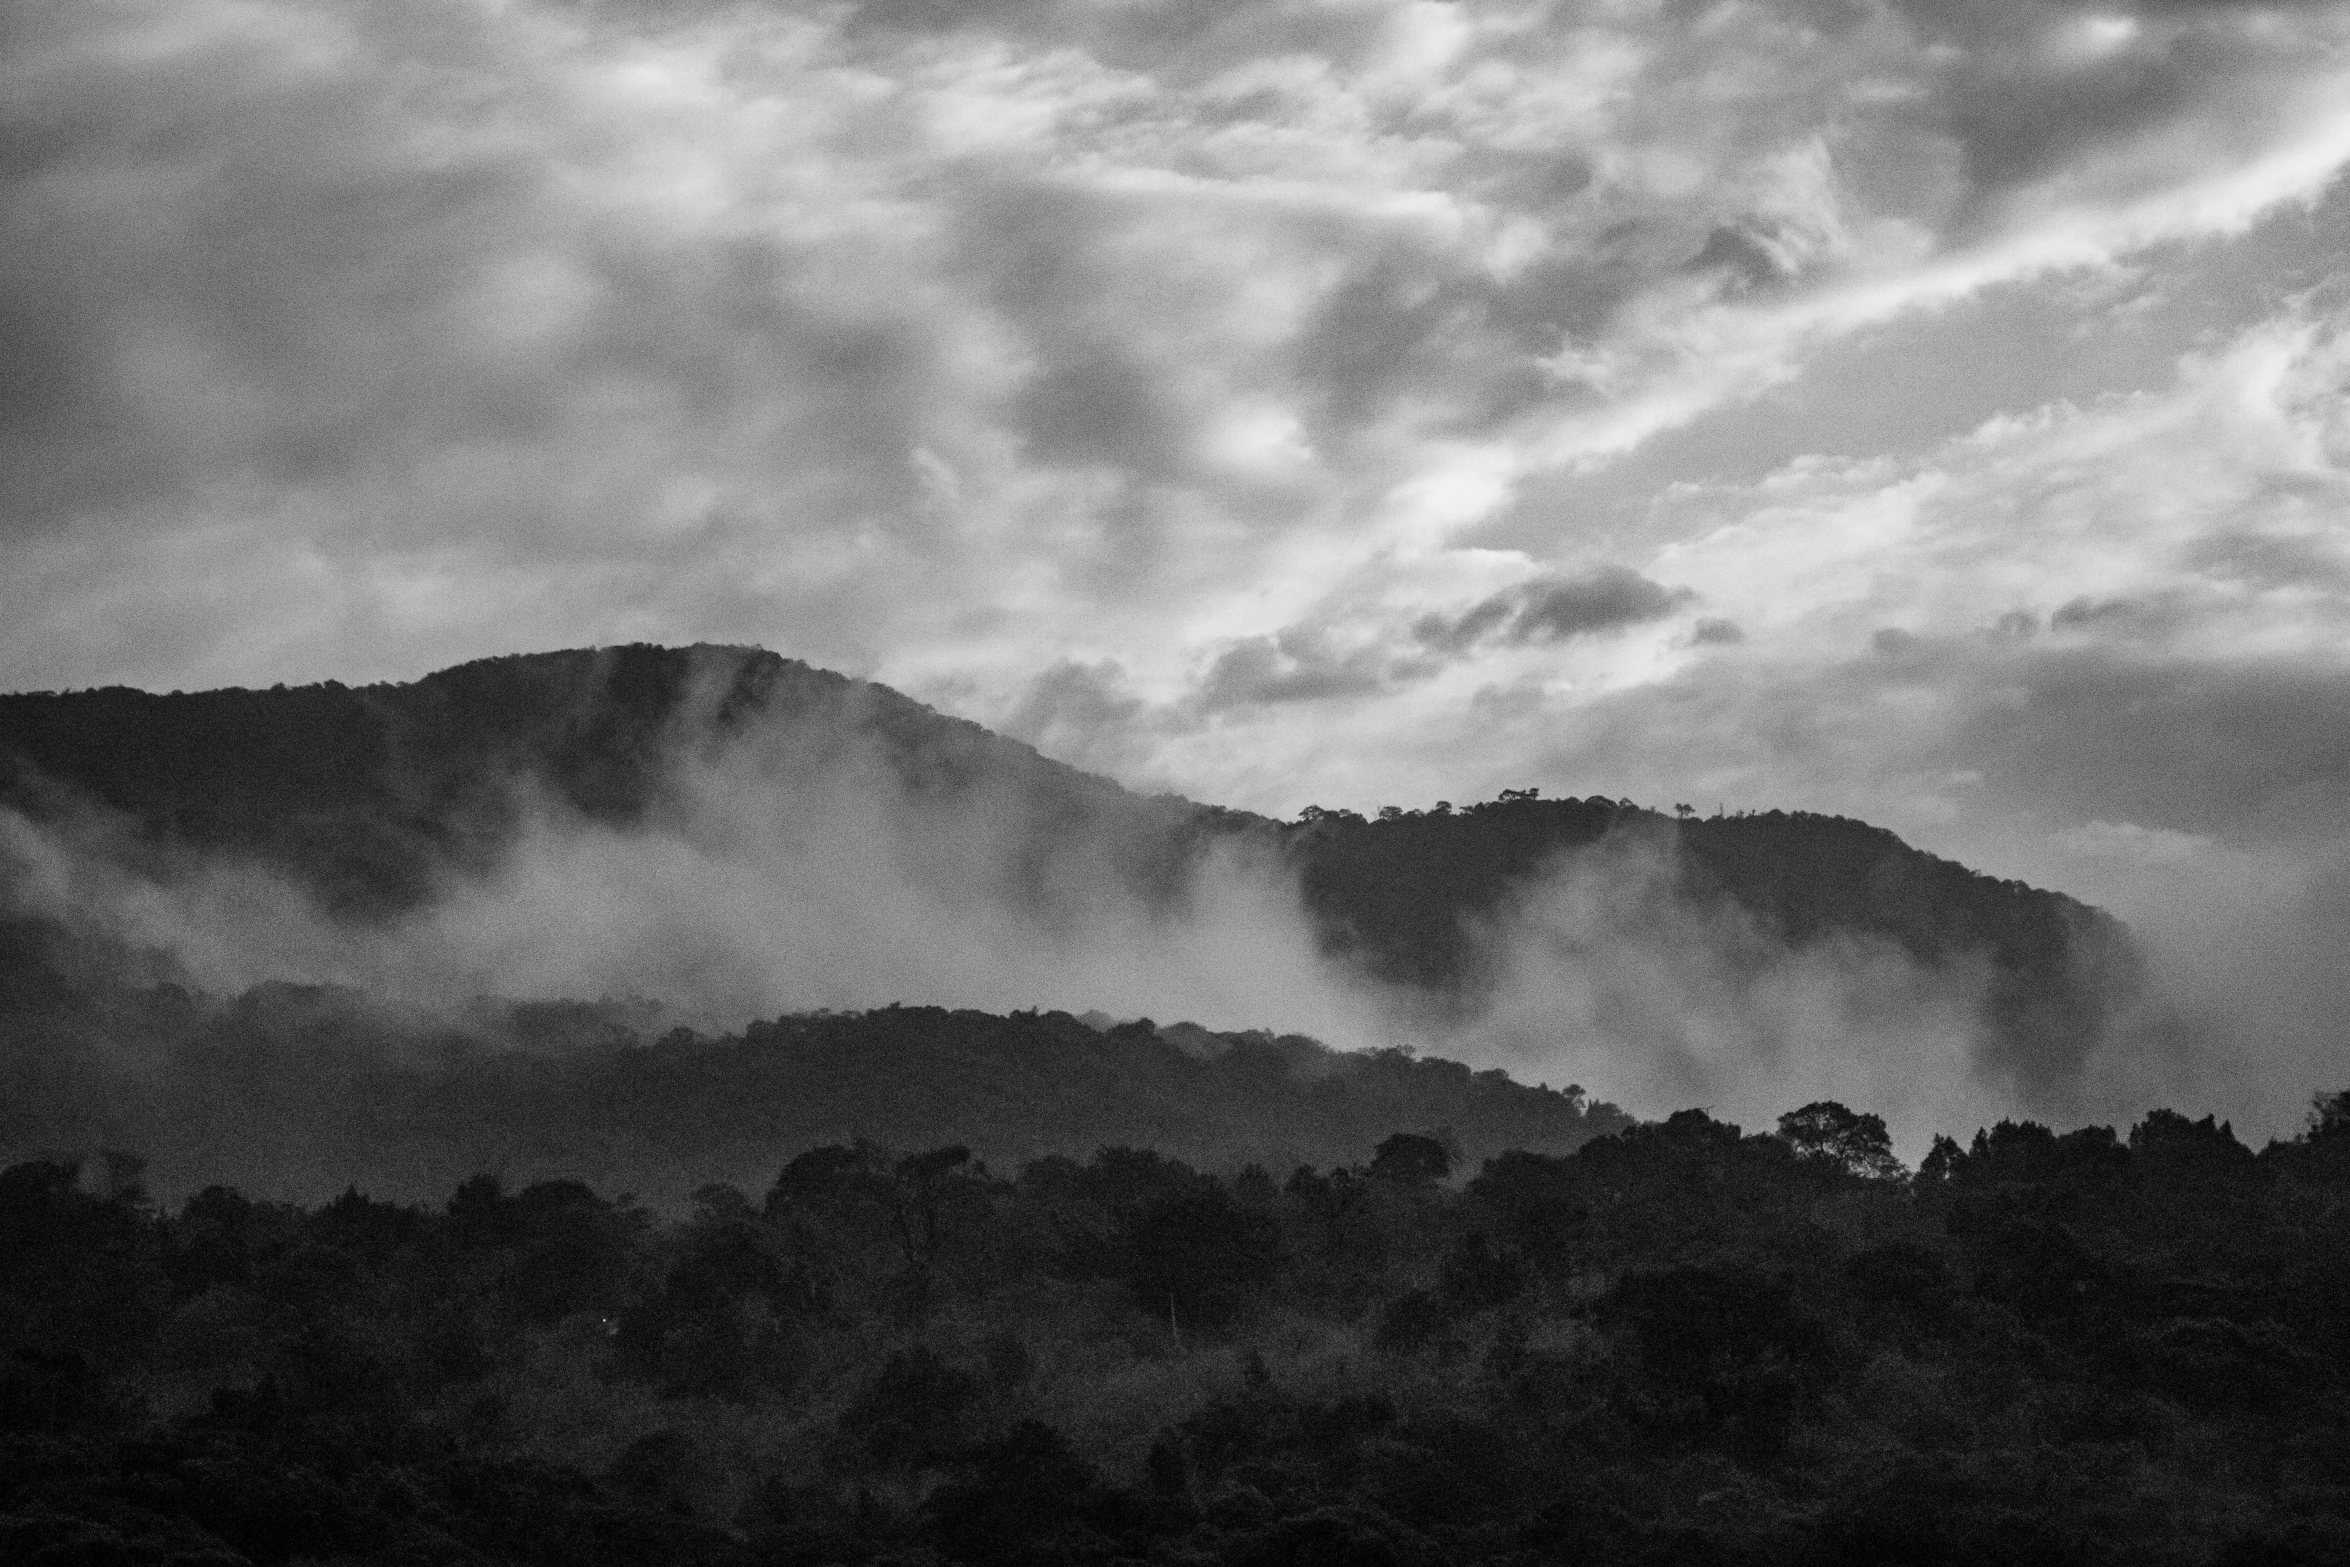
left=0, top=0, right=2350, bottom=702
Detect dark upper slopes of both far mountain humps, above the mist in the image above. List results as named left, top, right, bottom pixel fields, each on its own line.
left=0, top=646, right=2134, bottom=1081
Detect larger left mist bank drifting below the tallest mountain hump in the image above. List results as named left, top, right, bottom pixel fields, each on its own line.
left=0, top=693, right=1384, bottom=1043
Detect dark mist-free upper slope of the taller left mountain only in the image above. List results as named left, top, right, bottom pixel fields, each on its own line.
left=0, top=644, right=1222, bottom=914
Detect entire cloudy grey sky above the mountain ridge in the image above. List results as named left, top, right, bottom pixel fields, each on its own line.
left=0, top=0, right=2350, bottom=944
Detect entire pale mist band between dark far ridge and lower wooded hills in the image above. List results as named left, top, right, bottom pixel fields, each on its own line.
left=0, top=700, right=2237, bottom=1158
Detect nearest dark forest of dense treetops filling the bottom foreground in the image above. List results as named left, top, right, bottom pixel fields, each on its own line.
left=0, top=1095, right=2350, bottom=1567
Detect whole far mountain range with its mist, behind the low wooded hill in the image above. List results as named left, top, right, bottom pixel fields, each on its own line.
left=0, top=646, right=2176, bottom=1174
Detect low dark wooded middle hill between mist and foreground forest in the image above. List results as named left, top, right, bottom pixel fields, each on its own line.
left=0, top=972, right=1631, bottom=1208
